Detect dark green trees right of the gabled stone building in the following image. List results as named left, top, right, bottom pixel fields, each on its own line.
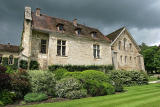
left=140, top=44, right=160, bottom=73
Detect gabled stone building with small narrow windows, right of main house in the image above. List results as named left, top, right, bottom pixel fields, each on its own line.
left=107, top=27, right=145, bottom=70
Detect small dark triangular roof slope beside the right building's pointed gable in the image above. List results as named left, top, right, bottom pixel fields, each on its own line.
left=107, top=27, right=124, bottom=42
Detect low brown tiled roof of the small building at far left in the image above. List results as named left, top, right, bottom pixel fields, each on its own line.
left=0, top=44, right=19, bottom=53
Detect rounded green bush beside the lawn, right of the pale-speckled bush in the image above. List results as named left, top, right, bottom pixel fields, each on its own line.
left=84, top=80, right=115, bottom=96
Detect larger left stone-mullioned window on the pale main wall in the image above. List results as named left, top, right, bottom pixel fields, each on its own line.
left=57, top=40, right=66, bottom=56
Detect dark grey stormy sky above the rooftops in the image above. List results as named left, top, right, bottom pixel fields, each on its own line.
left=0, top=0, right=160, bottom=45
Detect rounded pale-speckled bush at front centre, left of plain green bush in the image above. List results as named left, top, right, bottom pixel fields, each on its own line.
left=55, top=78, right=84, bottom=98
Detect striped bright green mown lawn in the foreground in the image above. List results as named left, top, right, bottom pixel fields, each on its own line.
left=25, top=84, right=160, bottom=107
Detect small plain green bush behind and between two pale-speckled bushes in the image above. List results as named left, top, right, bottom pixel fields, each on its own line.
left=54, top=68, right=68, bottom=80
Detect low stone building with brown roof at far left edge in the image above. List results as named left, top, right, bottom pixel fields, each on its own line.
left=0, top=44, right=19, bottom=65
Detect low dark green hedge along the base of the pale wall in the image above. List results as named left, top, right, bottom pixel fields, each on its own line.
left=48, top=65, right=113, bottom=72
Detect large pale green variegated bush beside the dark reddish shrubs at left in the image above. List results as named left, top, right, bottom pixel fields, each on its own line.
left=29, top=70, right=56, bottom=95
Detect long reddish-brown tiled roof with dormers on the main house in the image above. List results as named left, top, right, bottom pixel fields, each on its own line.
left=32, top=12, right=110, bottom=42
